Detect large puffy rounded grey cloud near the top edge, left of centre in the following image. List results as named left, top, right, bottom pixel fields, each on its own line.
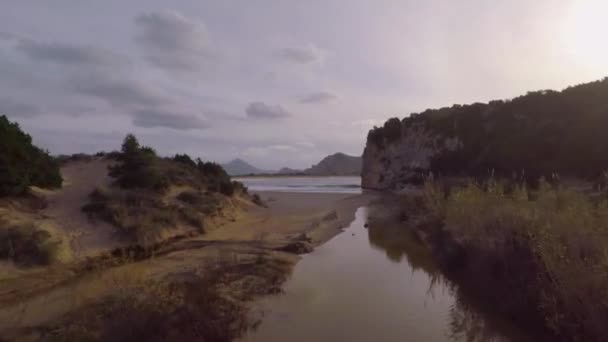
left=135, top=11, right=216, bottom=71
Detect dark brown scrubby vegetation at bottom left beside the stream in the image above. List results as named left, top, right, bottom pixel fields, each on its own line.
left=30, top=254, right=291, bottom=342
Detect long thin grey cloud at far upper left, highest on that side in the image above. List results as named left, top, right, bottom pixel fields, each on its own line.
left=17, top=39, right=129, bottom=67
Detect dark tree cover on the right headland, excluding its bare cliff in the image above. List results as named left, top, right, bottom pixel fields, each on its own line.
left=368, top=78, right=608, bottom=179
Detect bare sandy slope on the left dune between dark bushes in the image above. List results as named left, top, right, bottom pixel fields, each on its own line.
left=42, top=159, right=126, bottom=258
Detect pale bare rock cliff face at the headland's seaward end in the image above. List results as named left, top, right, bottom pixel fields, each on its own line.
left=361, top=127, right=461, bottom=190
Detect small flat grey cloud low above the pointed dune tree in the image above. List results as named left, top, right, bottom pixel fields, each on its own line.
left=133, top=109, right=208, bottom=131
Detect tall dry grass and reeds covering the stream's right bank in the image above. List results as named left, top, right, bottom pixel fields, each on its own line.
left=403, top=181, right=608, bottom=341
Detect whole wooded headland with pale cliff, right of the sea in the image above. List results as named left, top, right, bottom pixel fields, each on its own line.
left=362, top=78, right=608, bottom=189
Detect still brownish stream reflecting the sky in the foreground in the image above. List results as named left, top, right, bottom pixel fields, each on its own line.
left=242, top=208, right=528, bottom=342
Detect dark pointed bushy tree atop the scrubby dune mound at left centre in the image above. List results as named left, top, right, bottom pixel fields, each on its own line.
left=110, top=134, right=169, bottom=191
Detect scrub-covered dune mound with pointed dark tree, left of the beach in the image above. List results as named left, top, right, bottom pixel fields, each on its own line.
left=82, top=134, right=247, bottom=245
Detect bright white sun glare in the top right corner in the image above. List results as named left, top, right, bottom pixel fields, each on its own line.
left=562, top=0, right=608, bottom=72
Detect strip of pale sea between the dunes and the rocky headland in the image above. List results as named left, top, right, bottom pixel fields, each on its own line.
left=235, top=176, right=361, bottom=194
